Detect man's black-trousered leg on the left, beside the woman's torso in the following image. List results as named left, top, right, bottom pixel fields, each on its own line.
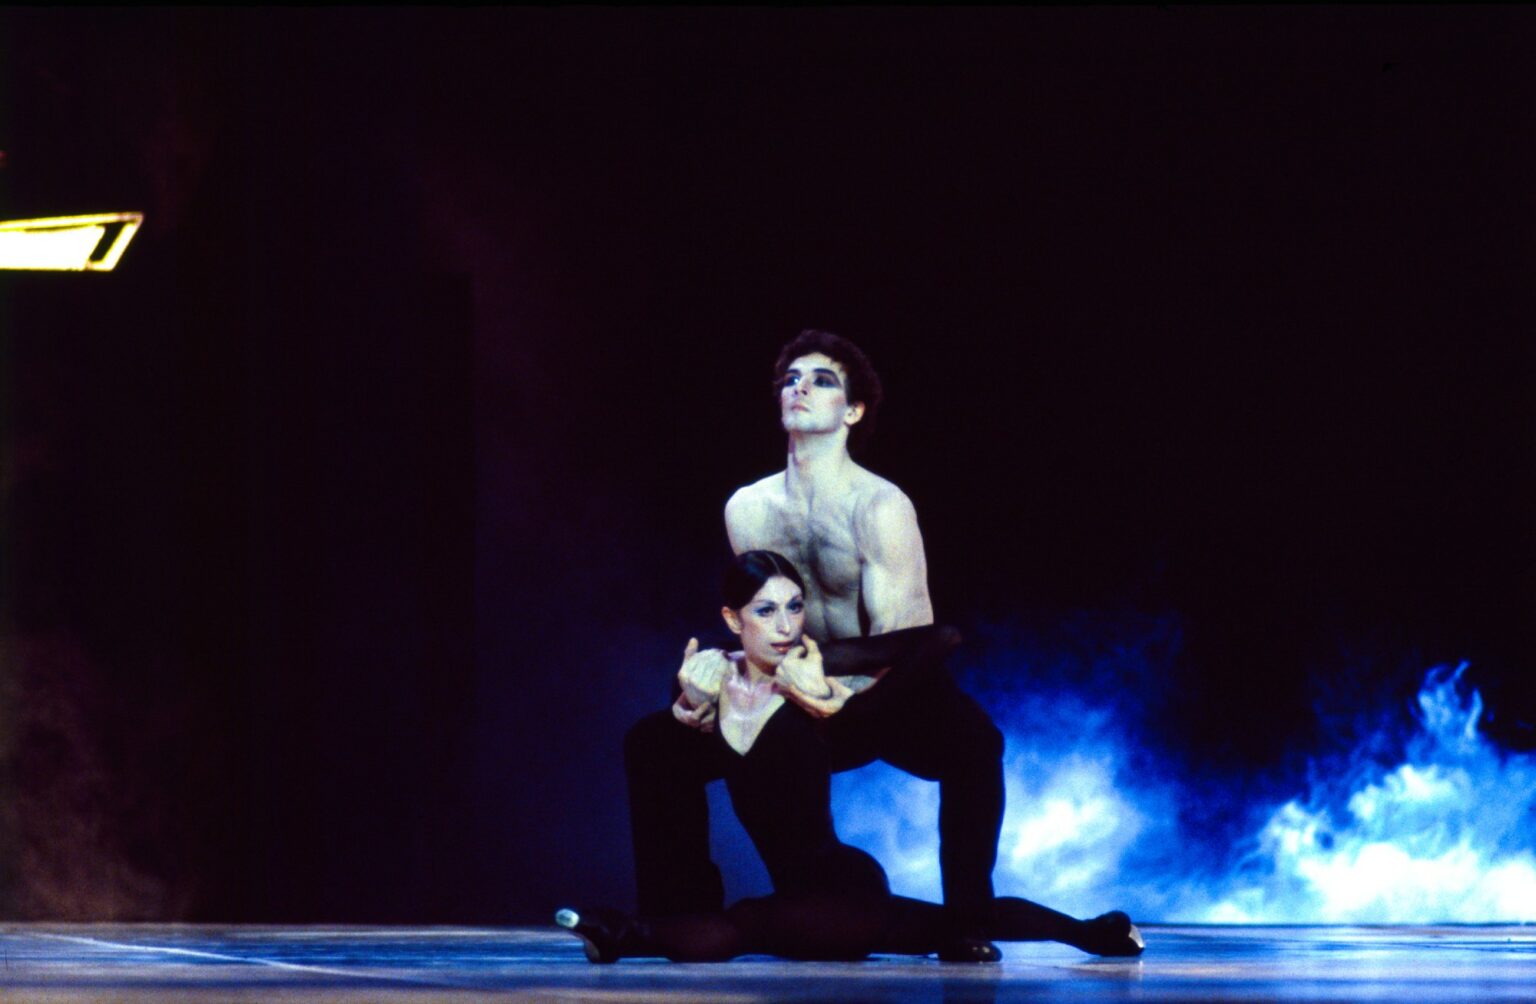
left=624, top=709, right=725, bottom=916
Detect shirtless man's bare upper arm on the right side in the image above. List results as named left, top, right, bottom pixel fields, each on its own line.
left=859, top=487, right=934, bottom=634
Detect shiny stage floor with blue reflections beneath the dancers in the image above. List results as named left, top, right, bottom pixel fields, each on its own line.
left=0, top=924, right=1536, bottom=1004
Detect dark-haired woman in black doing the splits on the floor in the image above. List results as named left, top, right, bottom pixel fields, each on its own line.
left=556, top=551, right=1141, bottom=963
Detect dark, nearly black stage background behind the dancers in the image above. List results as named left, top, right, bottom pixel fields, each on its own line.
left=0, top=8, right=1536, bottom=923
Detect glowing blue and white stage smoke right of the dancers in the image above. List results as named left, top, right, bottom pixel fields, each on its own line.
left=833, top=620, right=1536, bottom=924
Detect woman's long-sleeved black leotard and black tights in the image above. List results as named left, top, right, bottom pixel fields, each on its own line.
left=608, top=625, right=1129, bottom=961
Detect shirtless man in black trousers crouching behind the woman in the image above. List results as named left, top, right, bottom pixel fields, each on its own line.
left=625, top=330, right=1003, bottom=963
